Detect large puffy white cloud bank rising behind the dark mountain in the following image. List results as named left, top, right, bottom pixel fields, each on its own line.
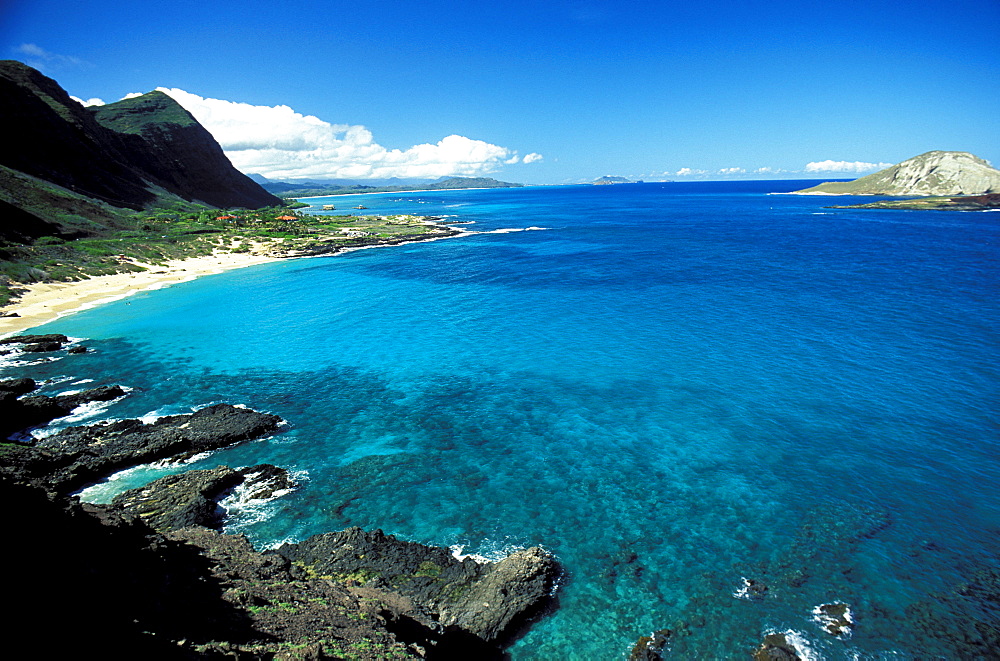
left=151, top=87, right=541, bottom=180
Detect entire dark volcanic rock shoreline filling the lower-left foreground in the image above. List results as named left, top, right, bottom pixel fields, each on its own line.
left=0, top=336, right=561, bottom=659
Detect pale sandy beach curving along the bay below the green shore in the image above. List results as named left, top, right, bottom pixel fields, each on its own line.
left=0, top=253, right=280, bottom=337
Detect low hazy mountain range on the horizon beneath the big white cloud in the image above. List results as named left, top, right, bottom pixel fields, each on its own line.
left=250, top=175, right=524, bottom=198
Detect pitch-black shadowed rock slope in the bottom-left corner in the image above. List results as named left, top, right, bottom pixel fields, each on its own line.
left=0, top=479, right=250, bottom=659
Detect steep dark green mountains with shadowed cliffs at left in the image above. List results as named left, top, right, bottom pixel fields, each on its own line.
left=0, top=60, right=282, bottom=242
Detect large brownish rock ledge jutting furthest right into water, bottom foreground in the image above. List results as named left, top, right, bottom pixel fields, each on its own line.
left=277, top=528, right=560, bottom=642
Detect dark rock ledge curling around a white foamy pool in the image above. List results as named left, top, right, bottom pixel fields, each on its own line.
left=111, top=464, right=292, bottom=532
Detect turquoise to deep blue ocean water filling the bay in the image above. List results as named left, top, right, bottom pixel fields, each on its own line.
left=6, top=182, right=1000, bottom=659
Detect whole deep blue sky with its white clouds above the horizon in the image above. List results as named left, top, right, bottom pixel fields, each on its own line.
left=0, top=0, right=1000, bottom=183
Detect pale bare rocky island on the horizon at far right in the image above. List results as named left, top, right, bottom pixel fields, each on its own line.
left=795, top=151, right=1000, bottom=195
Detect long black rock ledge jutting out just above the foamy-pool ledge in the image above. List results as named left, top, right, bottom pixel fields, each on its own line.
left=36, top=404, right=281, bottom=492
